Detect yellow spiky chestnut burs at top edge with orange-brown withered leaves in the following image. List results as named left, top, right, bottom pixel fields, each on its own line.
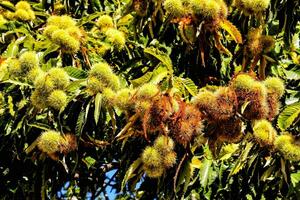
left=163, top=0, right=242, bottom=56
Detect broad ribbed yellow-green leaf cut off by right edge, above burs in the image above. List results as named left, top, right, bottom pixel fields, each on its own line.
left=277, top=102, right=300, bottom=131
